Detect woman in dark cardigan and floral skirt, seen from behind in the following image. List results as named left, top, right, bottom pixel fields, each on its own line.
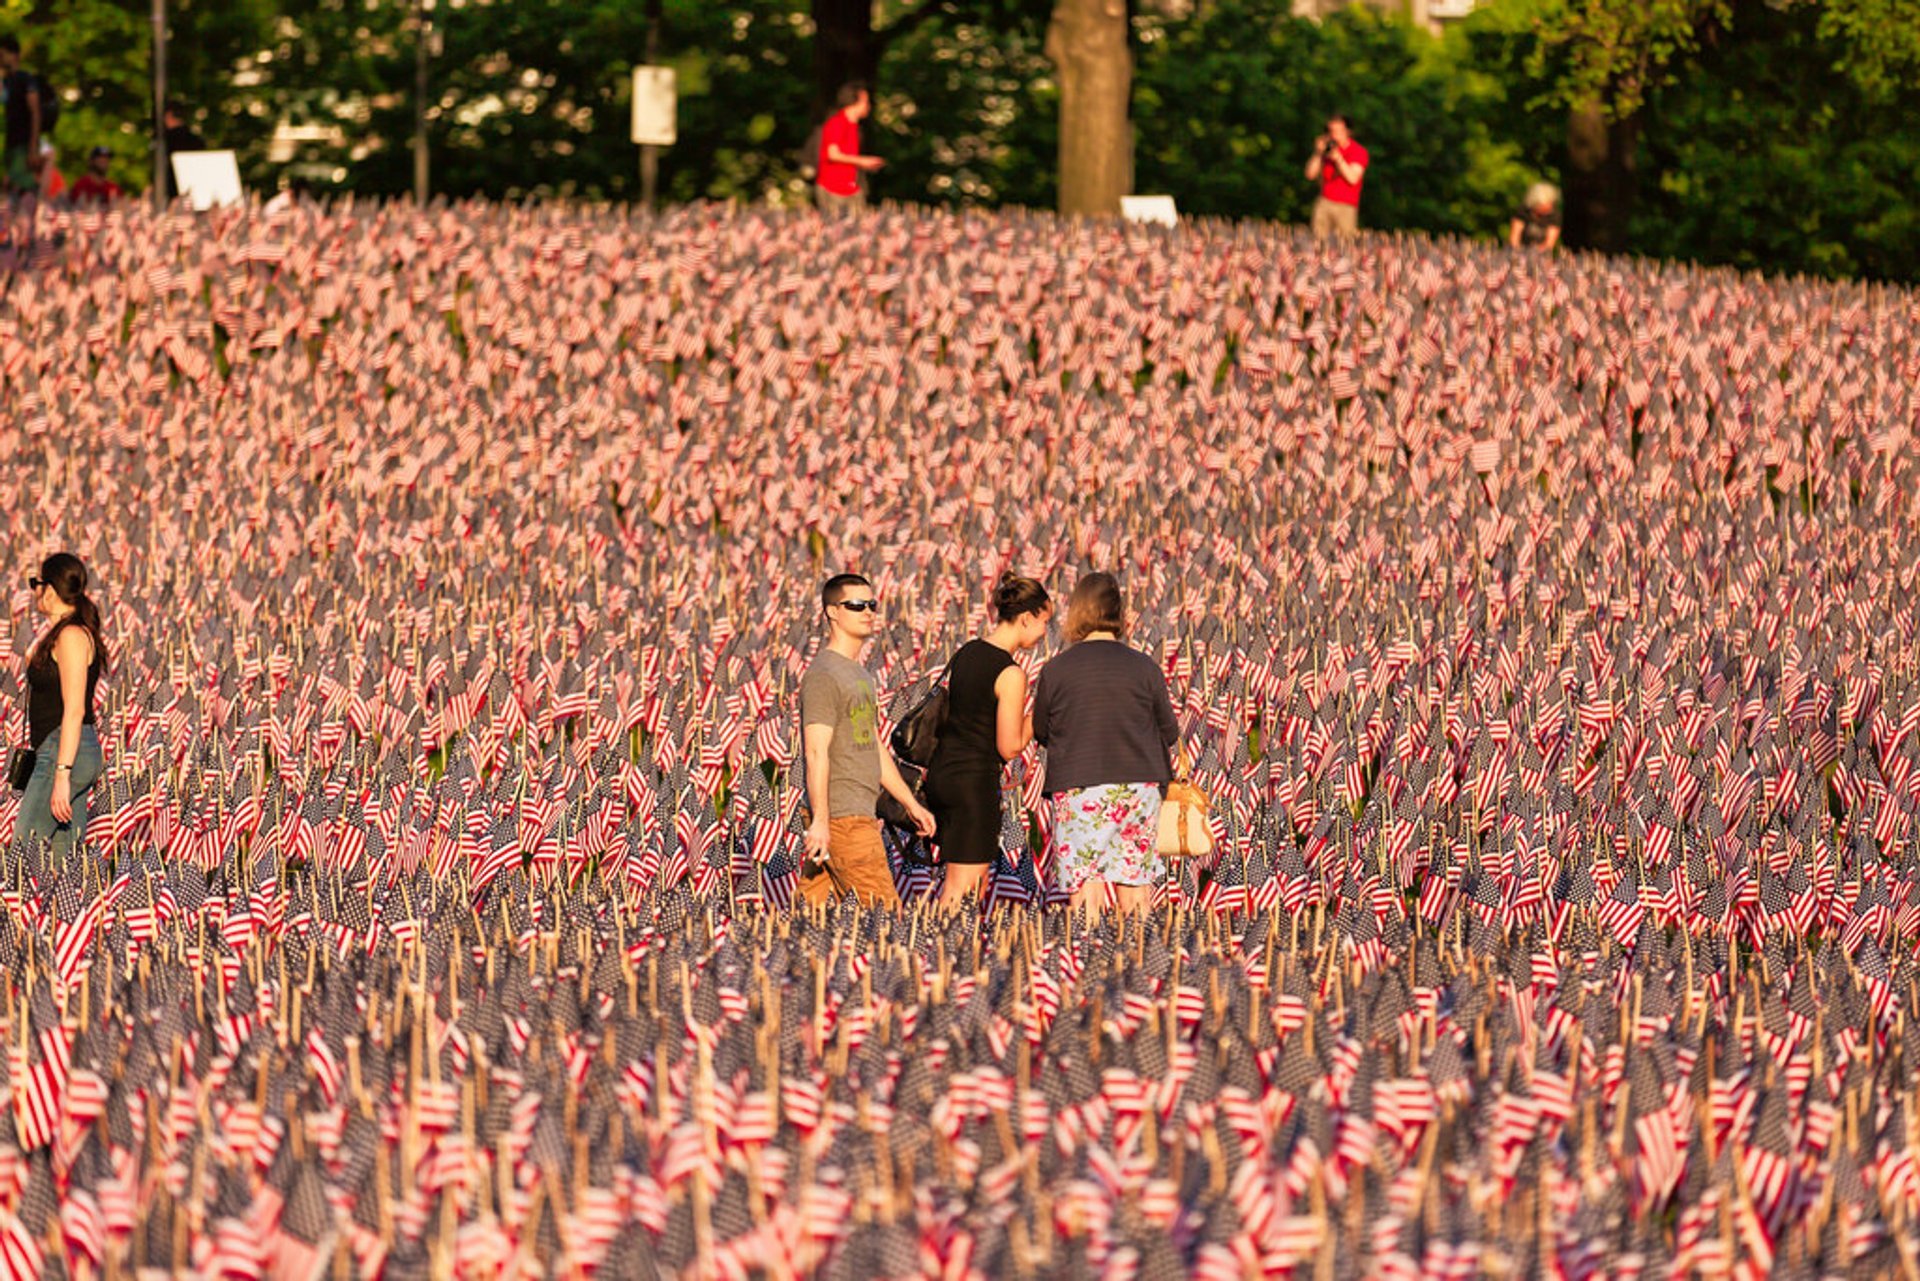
left=1033, top=574, right=1179, bottom=912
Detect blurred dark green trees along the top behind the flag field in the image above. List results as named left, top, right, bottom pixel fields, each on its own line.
left=0, top=0, right=1920, bottom=280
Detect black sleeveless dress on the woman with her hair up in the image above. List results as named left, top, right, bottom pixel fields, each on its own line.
left=925, top=640, right=1014, bottom=864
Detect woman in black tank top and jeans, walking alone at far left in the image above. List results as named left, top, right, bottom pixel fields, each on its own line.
left=13, top=551, right=108, bottom=857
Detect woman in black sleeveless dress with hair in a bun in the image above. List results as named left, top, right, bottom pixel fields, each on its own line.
left=927, top=574, right=1054, bottom=906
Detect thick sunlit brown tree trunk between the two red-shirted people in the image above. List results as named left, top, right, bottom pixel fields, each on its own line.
left=1046, top=0, right=1133, bottom=217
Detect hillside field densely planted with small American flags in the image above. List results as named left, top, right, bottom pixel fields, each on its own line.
left=0, top=193, right=1920, bottom=1281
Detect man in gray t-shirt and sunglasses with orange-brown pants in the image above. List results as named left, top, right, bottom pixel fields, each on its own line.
left=801, top=574, right=933, bottom=906
